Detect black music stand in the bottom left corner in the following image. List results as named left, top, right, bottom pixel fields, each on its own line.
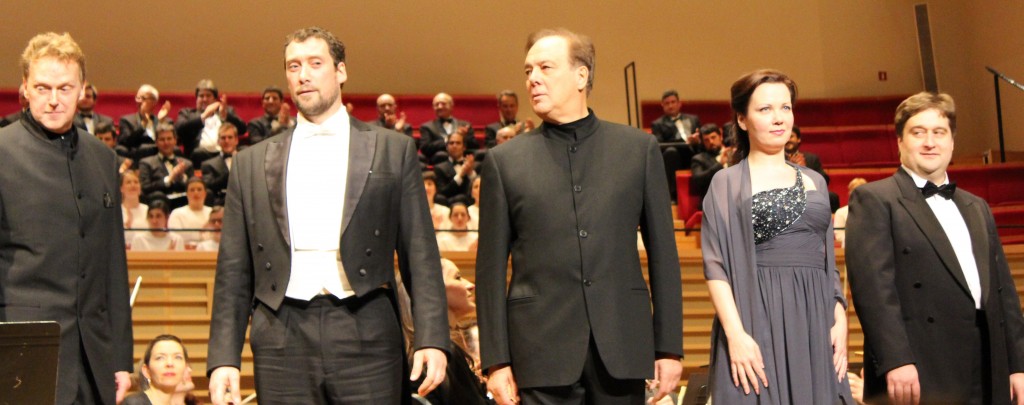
left=0, top=321, right=60, bottom=404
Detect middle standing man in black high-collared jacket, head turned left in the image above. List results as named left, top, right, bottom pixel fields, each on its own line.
left=476, top=29, right=682, bottom=404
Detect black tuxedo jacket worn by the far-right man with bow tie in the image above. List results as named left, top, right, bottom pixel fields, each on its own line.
left=846, top=169, right=1024, bottom=403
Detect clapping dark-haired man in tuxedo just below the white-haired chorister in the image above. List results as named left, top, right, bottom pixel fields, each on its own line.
left=138, top=122, right=195, bottom=208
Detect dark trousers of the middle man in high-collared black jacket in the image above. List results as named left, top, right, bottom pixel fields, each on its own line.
left=519, top=335, right=653, bottom=405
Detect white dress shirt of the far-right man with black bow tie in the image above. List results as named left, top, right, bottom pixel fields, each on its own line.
left=903, top=166, right=981, bottom=309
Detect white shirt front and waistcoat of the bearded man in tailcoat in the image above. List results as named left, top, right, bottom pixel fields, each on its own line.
left=285, top=108, right=355, bottom=301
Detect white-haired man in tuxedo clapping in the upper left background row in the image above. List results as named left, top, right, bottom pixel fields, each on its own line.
left=118, top=84, right=171, bottom=162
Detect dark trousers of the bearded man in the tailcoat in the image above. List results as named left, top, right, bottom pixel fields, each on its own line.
left=250, top=289, right=404, bottom=404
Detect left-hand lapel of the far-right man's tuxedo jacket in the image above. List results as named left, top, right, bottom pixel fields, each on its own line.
left=894, top=168, right=971, bottom=296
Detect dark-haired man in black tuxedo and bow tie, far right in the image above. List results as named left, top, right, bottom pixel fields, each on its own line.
left=846, top=93, right=1024, bottom=404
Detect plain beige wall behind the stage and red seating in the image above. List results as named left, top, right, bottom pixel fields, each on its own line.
left=0, top=0, right=1024, bottom=153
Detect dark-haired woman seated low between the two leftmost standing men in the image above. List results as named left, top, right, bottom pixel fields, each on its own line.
left=121, top=334, right=198, bottom=405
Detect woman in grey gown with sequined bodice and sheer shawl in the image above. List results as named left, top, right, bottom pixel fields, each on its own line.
left=701, top=70, right=852, bottom=404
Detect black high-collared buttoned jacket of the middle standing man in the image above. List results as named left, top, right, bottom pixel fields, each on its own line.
left=476, top=113, right=682, bottom=388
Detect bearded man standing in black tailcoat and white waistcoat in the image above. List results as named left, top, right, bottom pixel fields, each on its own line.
left=207, top=27, right=450, bottom=404
